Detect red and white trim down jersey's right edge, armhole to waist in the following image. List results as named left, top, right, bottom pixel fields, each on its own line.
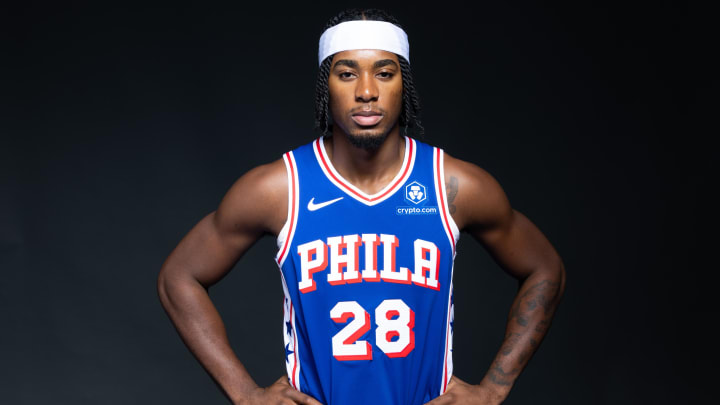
left=433, top=148, right=460, bottom=395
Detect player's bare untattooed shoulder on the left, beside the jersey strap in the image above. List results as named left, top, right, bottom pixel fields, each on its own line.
left=215, top=159, right=288, bottom=240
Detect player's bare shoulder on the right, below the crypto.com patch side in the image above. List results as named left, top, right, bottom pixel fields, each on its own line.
left=444, top=153, right=513, bottom=231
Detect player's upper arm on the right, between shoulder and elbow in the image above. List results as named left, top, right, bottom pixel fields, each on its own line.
left=472, top=209, right=556, bottom=279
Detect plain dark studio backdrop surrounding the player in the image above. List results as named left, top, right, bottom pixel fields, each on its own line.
left=0, top=2, right=715, bottom=404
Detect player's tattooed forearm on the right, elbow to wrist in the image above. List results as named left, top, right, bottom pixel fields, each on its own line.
left=481, top=265, right=565, bottom=400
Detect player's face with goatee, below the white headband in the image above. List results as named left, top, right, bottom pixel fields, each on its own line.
left=328, top=49, right=402, bottom=149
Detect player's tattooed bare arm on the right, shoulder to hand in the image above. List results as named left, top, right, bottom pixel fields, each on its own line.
left=430, top=155, right=565, bottom=403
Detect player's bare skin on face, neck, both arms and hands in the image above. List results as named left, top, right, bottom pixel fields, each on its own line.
left=158, top=50, right=565, bottom=405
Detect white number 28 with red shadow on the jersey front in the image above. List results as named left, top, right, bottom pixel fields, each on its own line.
left=330, top=299, right=415, bottom=361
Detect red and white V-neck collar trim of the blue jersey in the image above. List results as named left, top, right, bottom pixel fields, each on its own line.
left=313, top=137, right=417, bottom=206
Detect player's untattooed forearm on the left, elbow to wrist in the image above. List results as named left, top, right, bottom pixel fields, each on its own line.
left=158, top=275, right=258, bottom=403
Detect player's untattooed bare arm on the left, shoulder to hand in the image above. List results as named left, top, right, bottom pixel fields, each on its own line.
left=157, top=160, right=318, bottom=404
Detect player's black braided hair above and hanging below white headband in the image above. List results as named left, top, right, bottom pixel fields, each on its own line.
left=315, top=8, right=424, bottom=136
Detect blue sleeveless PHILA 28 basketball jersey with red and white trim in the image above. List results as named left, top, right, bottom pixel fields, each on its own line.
left=275, top=137, right=459, bottom=405
